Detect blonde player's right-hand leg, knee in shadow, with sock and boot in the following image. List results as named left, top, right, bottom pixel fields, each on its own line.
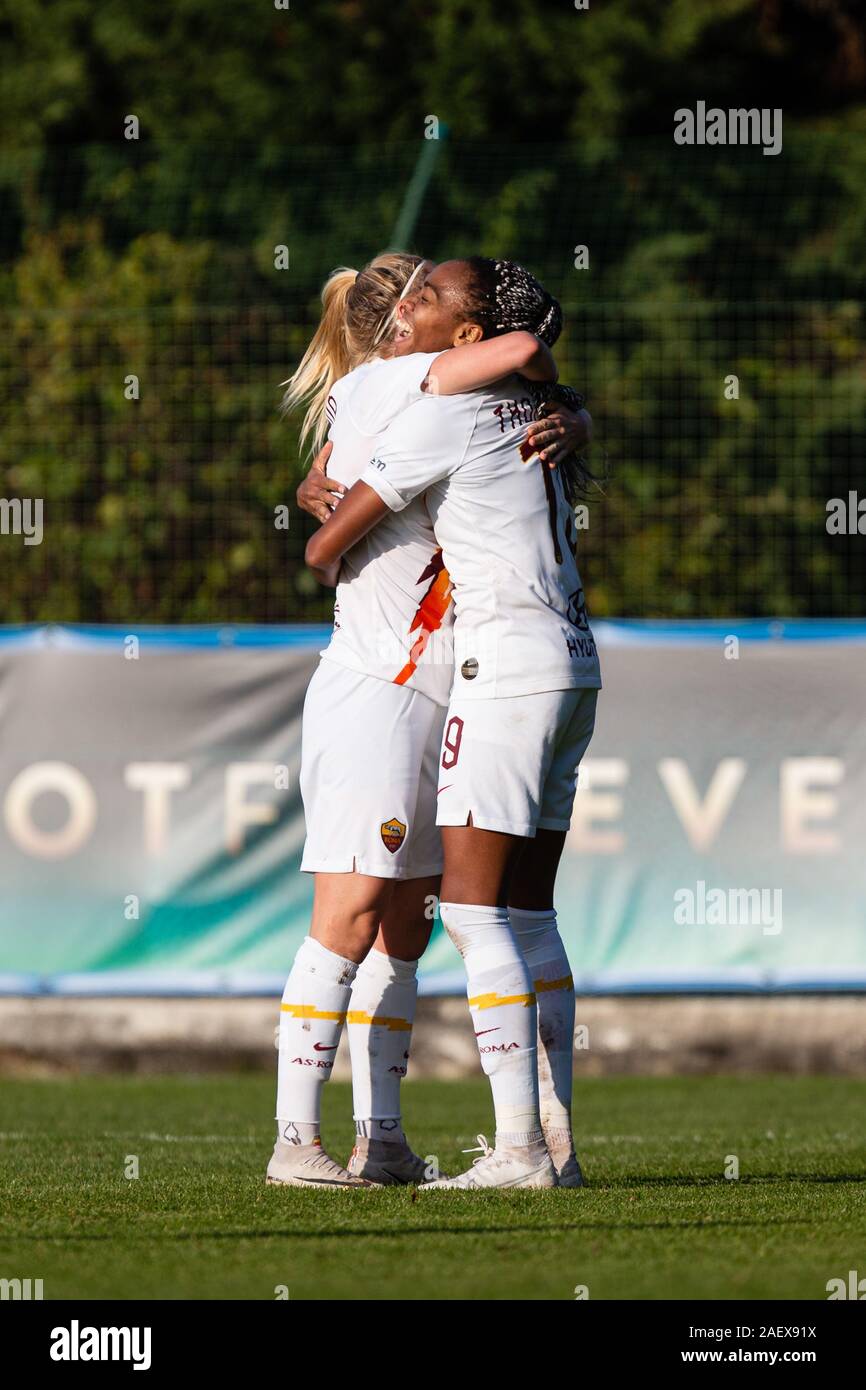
left=346, top=876, right=439, bottom=1186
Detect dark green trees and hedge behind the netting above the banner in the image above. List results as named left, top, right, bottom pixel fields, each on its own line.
left=0, top=0, right=866, bottom=623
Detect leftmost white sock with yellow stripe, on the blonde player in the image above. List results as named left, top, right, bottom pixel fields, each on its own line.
left=277, top=937, right=357, bottom=1144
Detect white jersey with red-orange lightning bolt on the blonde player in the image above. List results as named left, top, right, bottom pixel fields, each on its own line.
left=321, top=353, right=453, bottom=705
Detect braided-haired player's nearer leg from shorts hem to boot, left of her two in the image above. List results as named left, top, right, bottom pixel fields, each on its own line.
left=421, top=824, right=556, bottom=1191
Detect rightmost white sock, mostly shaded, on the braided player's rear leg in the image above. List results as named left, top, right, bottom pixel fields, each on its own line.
left=509, top=908, right=574, bottom=1148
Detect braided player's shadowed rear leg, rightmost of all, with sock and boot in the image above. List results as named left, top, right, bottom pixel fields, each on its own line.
left=509, top=830, right=582, bottom=1187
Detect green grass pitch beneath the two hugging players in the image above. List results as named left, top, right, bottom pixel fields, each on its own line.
left=0, top=1074, right=866, bottom=1300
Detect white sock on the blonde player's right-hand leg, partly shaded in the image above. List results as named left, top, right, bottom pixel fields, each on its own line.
left=346, top=949, right=418, bottom=1143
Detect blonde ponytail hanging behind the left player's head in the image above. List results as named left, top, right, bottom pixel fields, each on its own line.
left=281, top=265, right=357, bottom=453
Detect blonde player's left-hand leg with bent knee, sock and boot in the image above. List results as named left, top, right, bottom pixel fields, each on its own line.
left=267, top=873, right=393, bottom=1188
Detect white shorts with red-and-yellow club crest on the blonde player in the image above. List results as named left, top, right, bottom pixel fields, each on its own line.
left=300, top=660, right=445, bottom=878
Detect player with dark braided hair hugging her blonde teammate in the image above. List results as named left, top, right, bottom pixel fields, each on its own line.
left=307, top=259, right=601, bottom=1190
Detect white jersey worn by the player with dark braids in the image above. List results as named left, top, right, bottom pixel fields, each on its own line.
left=363, top=377, right=602, bottom=699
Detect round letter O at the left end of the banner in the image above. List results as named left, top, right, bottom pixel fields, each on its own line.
left=3, top=763, right=96, bottom=859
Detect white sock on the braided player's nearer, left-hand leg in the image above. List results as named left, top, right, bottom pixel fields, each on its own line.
left=439, top=902, right=542, bottom=1147
